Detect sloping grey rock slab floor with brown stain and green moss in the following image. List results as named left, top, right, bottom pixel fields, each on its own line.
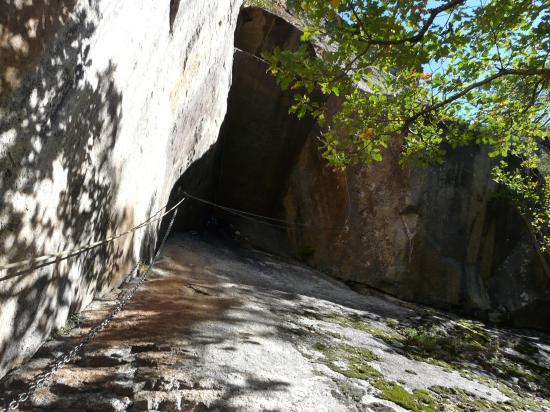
left=2, top=235, right=550, bottom=411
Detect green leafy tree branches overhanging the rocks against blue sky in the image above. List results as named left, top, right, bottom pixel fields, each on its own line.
left=264, top=0, right=550, bottom=250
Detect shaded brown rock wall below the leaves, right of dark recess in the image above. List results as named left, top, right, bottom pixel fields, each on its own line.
left=285, top=136, right=550, bottom=330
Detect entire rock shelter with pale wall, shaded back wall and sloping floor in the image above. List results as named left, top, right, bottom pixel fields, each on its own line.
left=0, top=0, right=550, bottom=411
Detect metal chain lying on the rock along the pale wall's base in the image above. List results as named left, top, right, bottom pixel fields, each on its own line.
left=0, top=208, right=178, bottom=412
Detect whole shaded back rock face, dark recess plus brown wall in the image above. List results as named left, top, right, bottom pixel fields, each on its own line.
left=216, top=8, right=550, bottom=330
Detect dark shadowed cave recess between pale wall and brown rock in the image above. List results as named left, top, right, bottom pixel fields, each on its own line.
left=162, top=8, right=322, bottom=254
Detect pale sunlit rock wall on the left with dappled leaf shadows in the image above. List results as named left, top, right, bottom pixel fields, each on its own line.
left=0, top=0, right=240, bottom=376
